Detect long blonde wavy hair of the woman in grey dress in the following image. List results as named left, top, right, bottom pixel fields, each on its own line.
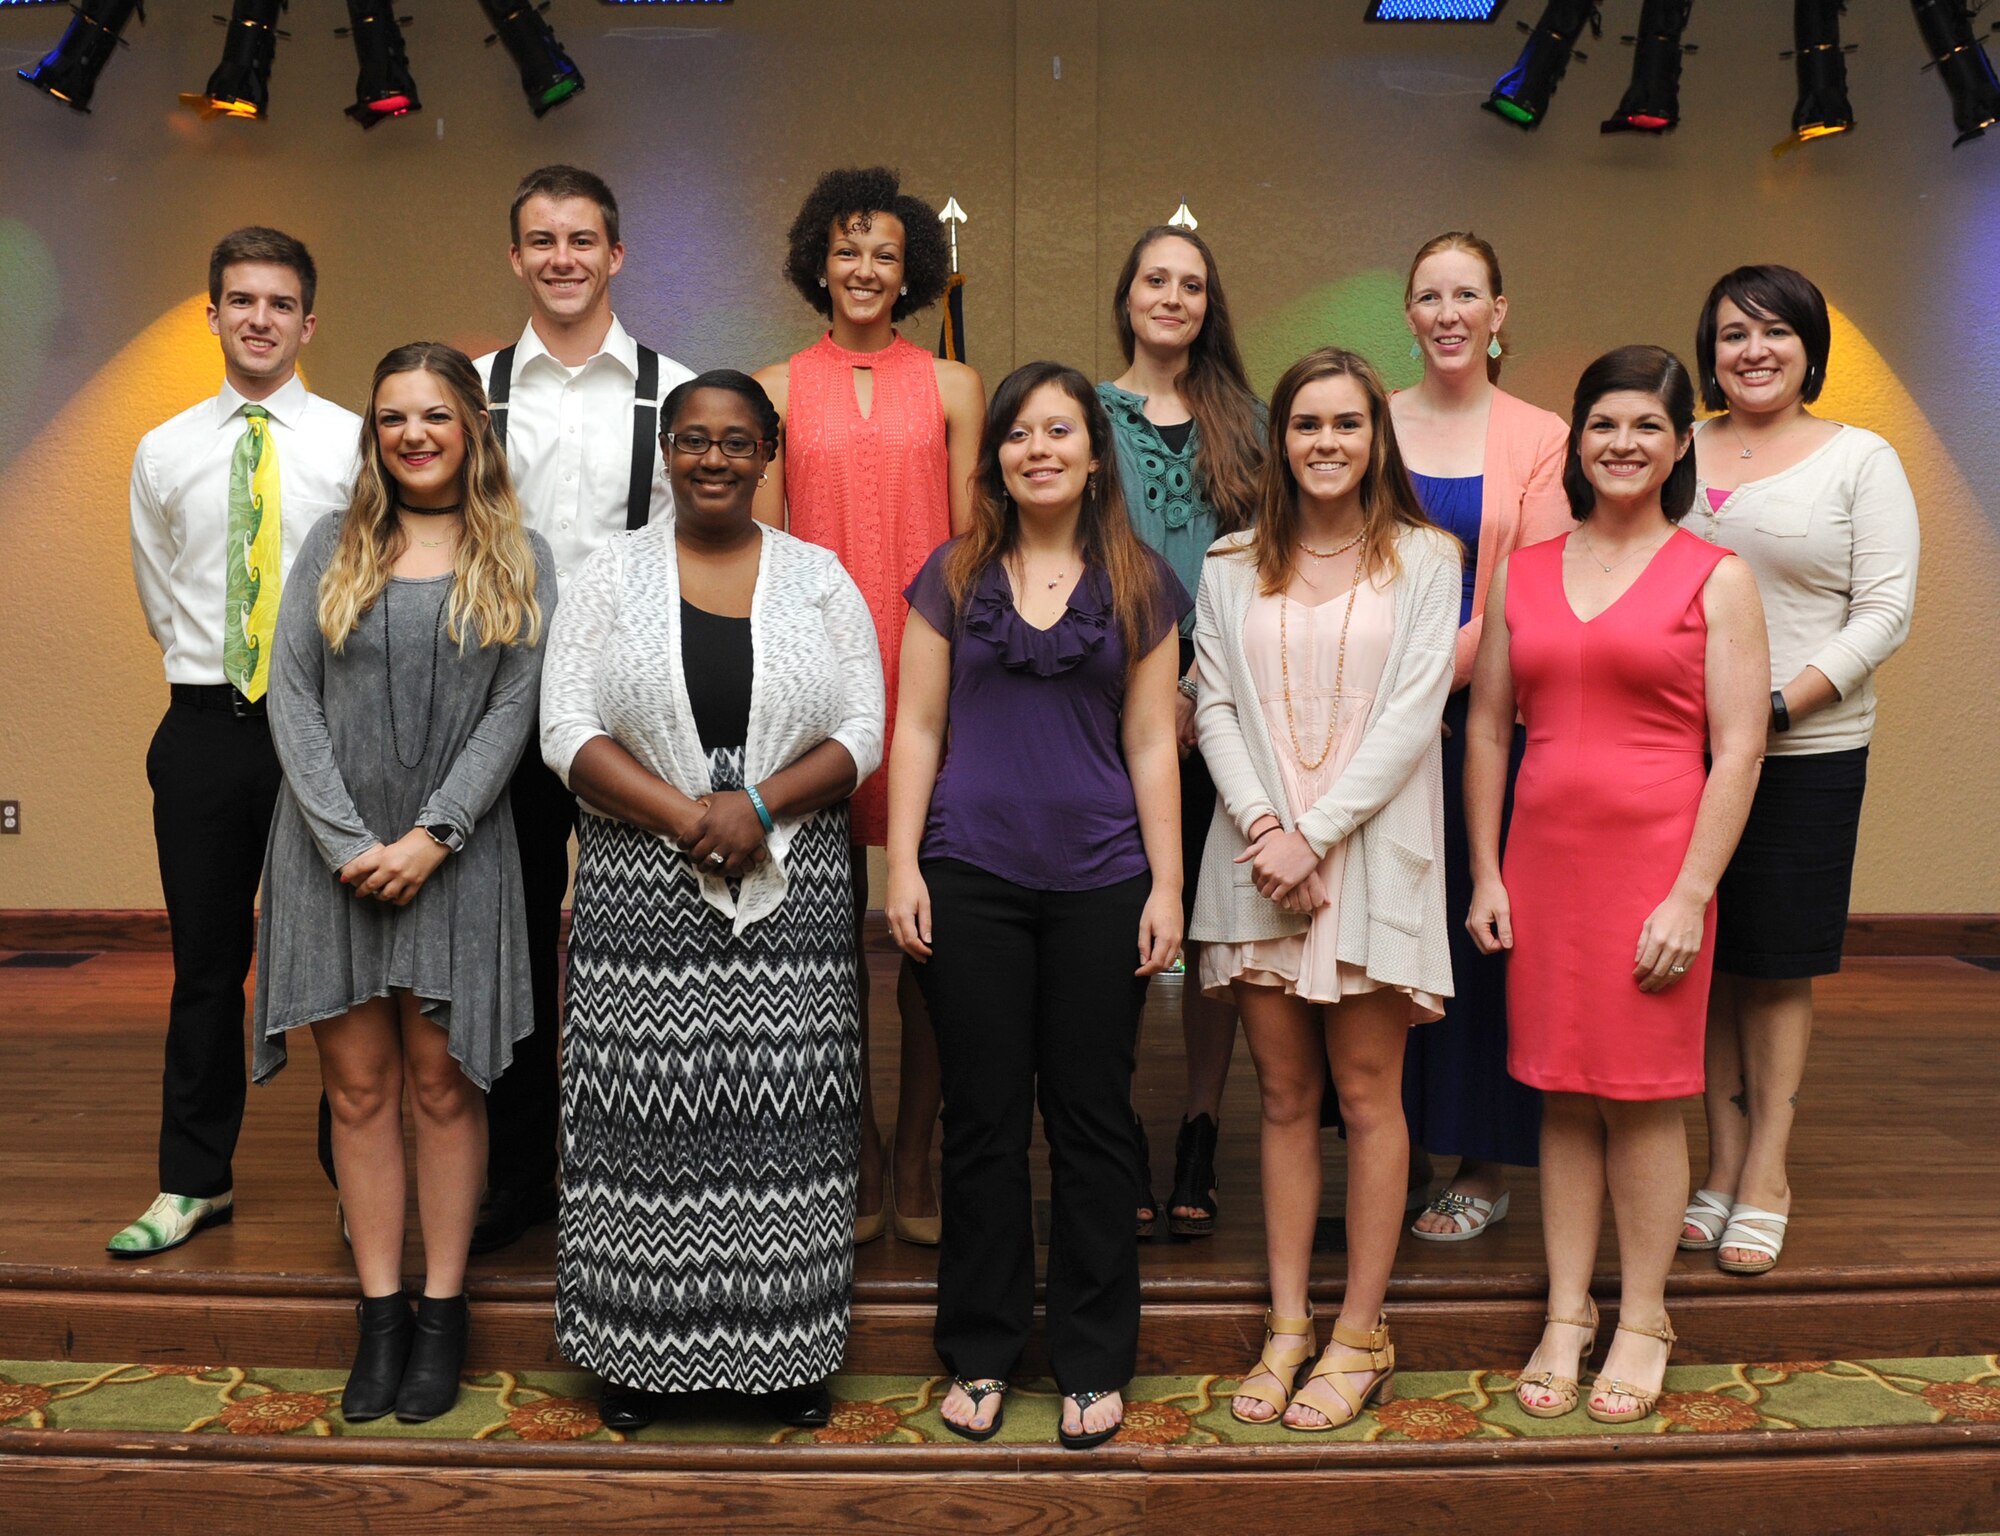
left=320, top=342, right=542, bottom=654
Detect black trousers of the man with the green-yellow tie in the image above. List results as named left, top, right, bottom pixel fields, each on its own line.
left=146, top=704, right=280, bottom=1200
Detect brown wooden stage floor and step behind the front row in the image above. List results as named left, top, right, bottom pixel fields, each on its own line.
left=0, top=944, right=2000, bottom=1370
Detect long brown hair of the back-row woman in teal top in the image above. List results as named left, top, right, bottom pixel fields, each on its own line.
left=1112, top=224, right=1264, bottom=534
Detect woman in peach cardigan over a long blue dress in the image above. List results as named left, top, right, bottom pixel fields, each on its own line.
left=1390, top=230, right=1570, bottom=1242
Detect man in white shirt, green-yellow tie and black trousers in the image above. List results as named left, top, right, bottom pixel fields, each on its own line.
left=106, top=228, right=360, bottom=1258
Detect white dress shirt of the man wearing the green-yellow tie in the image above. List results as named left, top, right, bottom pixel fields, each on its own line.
left=132, top=374, right=362, bottom=684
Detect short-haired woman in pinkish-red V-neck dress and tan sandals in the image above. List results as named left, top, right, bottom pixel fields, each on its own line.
left=1466, top=346, right=1770, bottom=1424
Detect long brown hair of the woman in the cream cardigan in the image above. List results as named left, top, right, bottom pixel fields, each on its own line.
left=1252, top=346, right=1432, bottom=594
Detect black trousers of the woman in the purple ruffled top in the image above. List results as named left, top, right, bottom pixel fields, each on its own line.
left=918, top=858, right=1152, bottom=1392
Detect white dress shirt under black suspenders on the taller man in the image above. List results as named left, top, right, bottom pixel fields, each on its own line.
left=474, top=316, right=694, bottom=588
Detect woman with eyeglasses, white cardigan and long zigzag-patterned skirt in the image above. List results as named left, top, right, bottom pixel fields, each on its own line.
left=542, top=370, right=882, bottom=1430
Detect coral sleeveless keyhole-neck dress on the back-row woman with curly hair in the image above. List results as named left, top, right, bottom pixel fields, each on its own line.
left=784, top=336, right=952, bottom=846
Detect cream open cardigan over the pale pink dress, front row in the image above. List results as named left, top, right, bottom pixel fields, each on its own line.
left=1188, top=528, right=1462, bottom=998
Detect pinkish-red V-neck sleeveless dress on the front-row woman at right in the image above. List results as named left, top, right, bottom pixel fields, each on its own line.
left=1502, top=530, right=1728, bottom=1100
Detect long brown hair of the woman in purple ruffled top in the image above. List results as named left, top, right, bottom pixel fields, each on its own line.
left=944, top=362, right=1166, bottom=668
